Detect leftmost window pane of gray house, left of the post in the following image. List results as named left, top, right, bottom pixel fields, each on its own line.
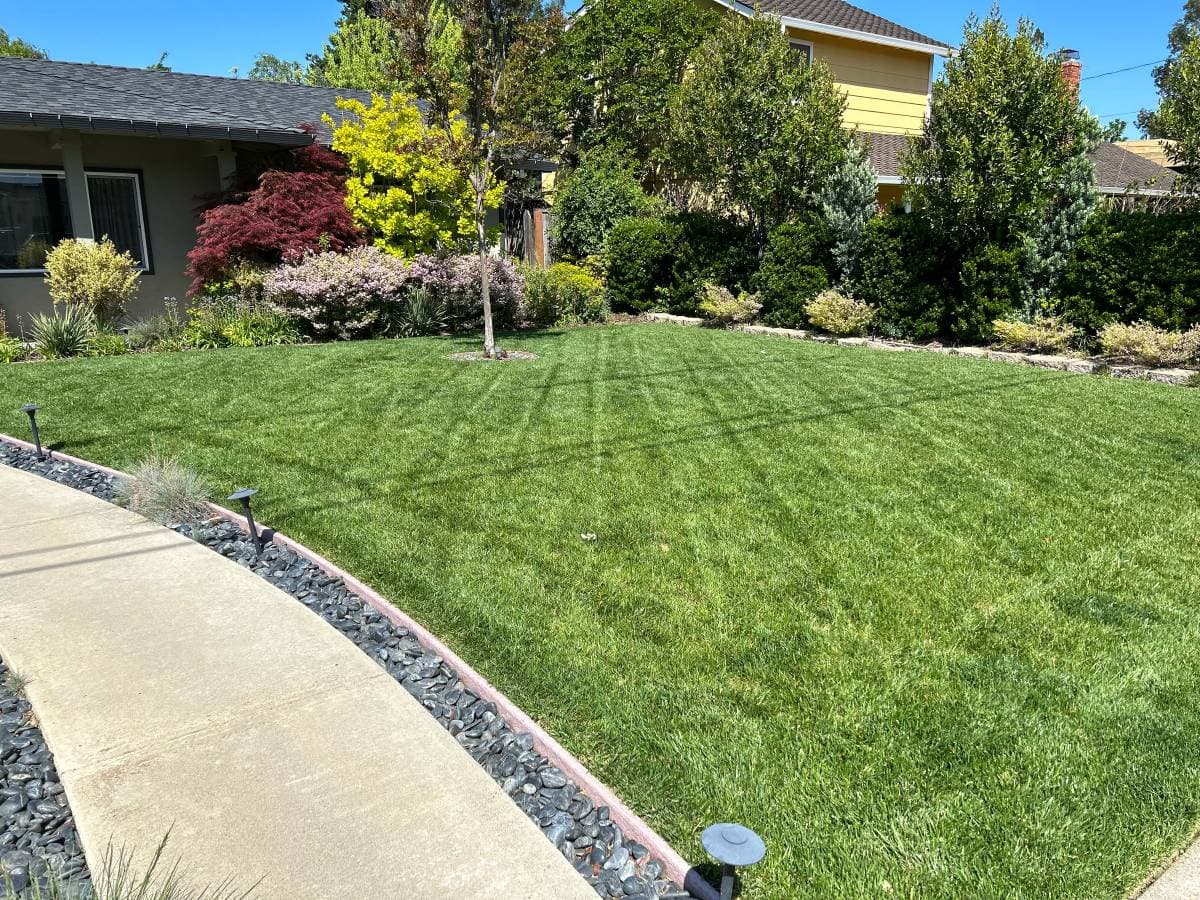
left=0, top=169, right=71, bottom=272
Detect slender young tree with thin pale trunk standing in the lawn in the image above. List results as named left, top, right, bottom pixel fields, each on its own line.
left=385, top=0, right=560, bottom=358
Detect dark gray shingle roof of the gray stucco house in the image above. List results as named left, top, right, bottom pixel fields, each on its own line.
left=0, top=58, right=371, bottom=145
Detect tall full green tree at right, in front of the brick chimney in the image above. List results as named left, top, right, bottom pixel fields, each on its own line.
left=901, top=11, right=1099, bottom=340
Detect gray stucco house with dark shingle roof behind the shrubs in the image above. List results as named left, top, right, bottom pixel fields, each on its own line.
left=0, top=58, right=370, bottom=330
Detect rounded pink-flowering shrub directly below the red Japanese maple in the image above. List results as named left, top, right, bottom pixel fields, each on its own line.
left=263, top=246, right=409, bottom=338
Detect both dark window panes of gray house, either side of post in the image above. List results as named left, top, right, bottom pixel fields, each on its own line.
left=0, top=169, right=150, bottom=275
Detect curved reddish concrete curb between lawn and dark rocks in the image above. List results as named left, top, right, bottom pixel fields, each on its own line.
left=0, top=432, right=720, bottom=900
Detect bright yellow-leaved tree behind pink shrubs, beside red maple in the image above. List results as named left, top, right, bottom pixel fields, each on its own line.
left=326, top=94, right=489, bottom=257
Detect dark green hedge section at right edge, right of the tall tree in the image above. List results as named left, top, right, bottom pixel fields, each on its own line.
left=1056, top=211, right=1200, bottom=334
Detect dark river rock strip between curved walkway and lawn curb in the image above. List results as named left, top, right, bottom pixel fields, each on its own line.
left=0, top=437, right=716, bottom=900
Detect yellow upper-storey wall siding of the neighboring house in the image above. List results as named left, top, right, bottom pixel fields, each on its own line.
left=787, top=29, right=934, bottom=134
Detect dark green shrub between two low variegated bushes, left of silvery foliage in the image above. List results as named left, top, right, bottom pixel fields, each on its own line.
left=751, top=217, right=832, bottom=328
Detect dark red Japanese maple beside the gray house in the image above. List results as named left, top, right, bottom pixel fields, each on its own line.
left=187, top=145, right=362, bottom=294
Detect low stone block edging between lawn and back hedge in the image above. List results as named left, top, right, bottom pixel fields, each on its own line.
left=646, top=312, right=1200, bottom=386
